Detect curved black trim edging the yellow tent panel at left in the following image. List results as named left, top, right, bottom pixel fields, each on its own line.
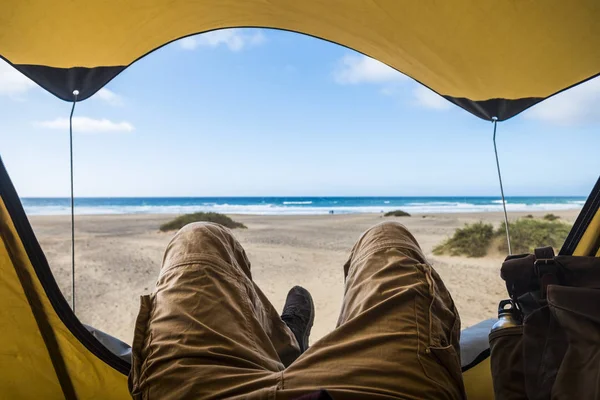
left=0, top=158, right=131, bottom=375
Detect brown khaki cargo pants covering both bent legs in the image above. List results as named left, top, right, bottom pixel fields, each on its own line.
left=129, top=222, right=465, bottom=399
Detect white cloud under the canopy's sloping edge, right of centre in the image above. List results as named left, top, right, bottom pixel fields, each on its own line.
left=333, top=54, right=406, bottom=85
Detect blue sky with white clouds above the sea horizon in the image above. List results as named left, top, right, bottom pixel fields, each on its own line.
left=0, top=29, right=600, bottom=197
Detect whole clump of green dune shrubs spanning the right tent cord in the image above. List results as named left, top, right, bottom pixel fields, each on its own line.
left=433, top=217, right=571, bottom=257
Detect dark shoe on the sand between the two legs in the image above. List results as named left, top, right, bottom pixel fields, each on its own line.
left=281, top=286, right=315, bottom=353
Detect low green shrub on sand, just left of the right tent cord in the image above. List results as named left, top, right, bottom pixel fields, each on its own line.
left=433, top=222, right=494, bottom=257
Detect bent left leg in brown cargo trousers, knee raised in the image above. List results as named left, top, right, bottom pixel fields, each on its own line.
left=130, top=223, right=300, bottom=399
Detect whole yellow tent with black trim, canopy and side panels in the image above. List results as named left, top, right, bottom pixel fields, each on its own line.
left=0, top=0, right=600, bottom=399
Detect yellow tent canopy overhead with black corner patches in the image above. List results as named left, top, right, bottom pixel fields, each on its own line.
left=0, top=0, right=600, bottom=120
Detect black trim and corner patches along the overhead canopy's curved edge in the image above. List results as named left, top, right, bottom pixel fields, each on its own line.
left=0, top=26, right=600, bottom=121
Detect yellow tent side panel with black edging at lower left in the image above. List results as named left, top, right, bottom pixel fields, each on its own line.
left=0, top=161, right=129, bottom=399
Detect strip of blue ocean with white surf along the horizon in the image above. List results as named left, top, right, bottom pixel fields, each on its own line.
left=21, top=196, right=585, bottom=215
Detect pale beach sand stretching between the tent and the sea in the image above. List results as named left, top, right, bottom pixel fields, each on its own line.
left=30, top=210, right=579, bottom=343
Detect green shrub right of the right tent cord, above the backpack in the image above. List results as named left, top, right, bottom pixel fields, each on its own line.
left=496, top=217, right=571, bottom=254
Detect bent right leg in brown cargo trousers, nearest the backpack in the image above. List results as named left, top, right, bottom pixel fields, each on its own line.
left=277, top=222, right=464, bottom=399
